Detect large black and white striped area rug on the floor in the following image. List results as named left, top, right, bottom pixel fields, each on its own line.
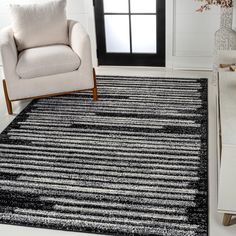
left=0, top=76, right=208, bottom=236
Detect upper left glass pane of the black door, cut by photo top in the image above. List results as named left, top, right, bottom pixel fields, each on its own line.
left=103, top=0, right=129, bottom=13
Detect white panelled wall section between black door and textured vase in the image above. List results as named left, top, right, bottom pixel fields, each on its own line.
left=166, top=0, right=220, bottom=69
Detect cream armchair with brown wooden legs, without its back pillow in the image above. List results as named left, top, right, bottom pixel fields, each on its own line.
left=0, top=20, right=97, bottom=114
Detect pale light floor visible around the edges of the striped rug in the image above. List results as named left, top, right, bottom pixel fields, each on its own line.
left=0, top=67, right=236, bottom=236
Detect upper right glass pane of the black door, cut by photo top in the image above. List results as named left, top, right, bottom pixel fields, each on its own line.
left=130, top=0, right=156, bottom=13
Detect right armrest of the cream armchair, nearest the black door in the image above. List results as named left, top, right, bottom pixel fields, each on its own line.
left=68, top=20, right=93, bottom=74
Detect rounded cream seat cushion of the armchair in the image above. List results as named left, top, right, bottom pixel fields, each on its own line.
left=16, top=45, right=81, bottom=79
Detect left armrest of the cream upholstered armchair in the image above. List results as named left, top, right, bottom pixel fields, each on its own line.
left=0, top=27, right=18, bottom=83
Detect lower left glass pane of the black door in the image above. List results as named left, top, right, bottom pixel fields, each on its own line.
left=105, top=15, right=130, bottom=52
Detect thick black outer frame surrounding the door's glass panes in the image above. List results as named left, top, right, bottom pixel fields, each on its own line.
left=94, top=0, right=166, bottom=67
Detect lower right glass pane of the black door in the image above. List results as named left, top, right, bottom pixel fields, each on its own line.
left=131, top=15, right=157, bottom=53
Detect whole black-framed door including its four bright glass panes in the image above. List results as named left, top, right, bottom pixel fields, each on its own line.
left=94, top=0, right=165, bottom=66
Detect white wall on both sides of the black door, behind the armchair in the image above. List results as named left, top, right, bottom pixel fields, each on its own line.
left=0, top=0, right=229, bottom=69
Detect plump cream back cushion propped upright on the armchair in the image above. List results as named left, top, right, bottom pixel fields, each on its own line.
left=10, top=0, right=69, bottom=51
